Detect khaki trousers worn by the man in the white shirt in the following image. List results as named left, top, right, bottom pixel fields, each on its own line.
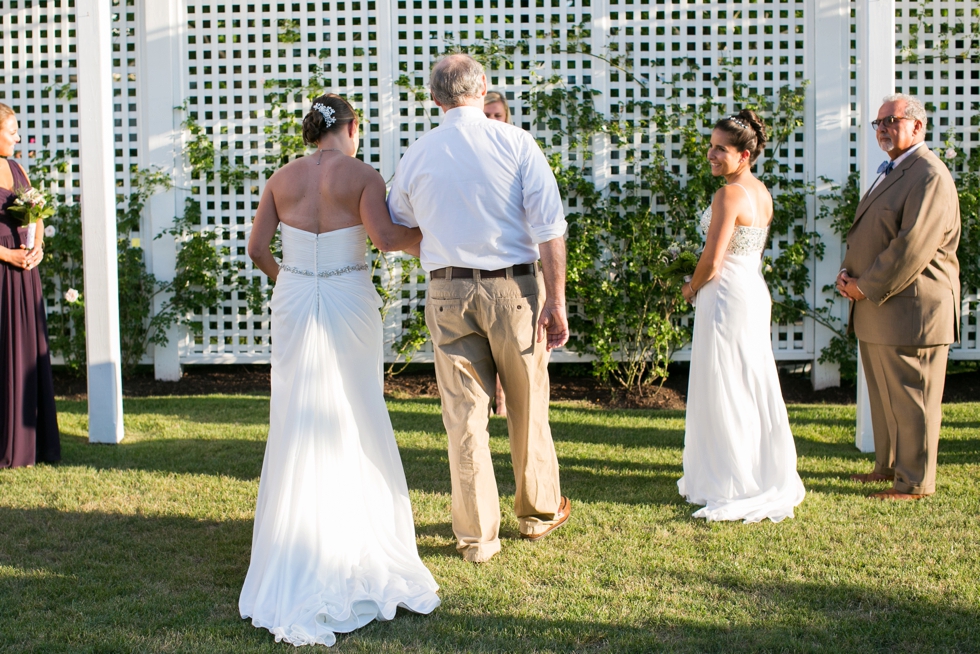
left=425, top=271, right=561, bottom=562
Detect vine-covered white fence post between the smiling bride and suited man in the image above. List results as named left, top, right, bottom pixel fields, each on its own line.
left=805, top=0, right=851, bottom=390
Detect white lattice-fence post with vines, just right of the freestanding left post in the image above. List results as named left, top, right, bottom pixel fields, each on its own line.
left=136, top=0, right=184, bottom=381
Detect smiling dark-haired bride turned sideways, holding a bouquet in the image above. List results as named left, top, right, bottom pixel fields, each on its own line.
left=677, top=110, right=805, bottom=522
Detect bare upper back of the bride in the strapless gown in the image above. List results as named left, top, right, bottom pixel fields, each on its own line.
left=269, top=150, right=374, bottom=234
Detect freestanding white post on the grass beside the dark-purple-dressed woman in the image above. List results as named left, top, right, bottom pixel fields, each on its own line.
left=77, top=0, right=123, bottom=443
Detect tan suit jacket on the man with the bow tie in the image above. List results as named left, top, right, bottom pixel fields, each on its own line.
left=843, top=145, right=960, bottom=347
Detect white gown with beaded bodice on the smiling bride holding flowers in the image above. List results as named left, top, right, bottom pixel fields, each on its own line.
left=677, top=184, right=806, bottom=522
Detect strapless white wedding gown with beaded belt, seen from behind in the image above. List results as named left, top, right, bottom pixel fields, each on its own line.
left=239, top=225, right=439, bottom=645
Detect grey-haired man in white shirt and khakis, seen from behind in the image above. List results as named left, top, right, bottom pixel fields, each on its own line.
left=388, top=55, right=571, bottom=562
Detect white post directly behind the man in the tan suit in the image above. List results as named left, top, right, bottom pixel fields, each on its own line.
left=854, top=0, right=895, bottom=452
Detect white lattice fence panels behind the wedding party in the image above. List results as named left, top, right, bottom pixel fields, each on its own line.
left=0, top=0, right=980, bottom=363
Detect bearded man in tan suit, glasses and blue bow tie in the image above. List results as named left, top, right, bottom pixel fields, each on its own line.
left=837, top=94, right=960, bottom=500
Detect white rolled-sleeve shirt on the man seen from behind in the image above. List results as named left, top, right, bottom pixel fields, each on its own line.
left=388, top=107, right=566, bottom=271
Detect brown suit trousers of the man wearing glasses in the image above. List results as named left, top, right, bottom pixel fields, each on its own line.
left=860, top=341, right=949, bottom=495
